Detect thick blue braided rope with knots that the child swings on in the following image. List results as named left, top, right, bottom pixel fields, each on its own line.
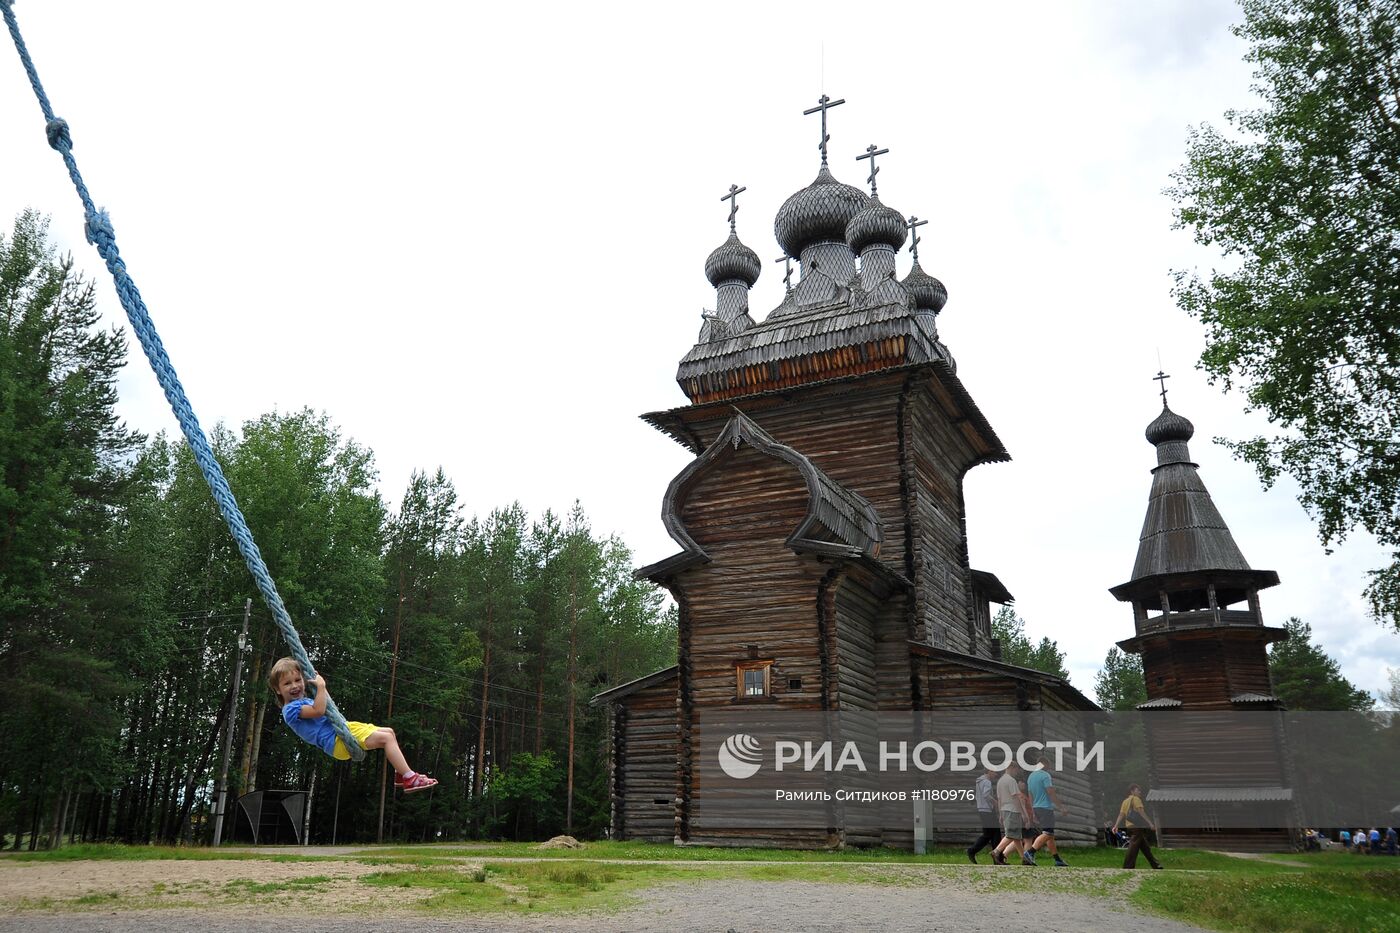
left=0, top=0, right=364, bottom=761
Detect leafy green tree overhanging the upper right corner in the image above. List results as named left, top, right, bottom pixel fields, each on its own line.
left=1169, top=0, right=1400, bottom=626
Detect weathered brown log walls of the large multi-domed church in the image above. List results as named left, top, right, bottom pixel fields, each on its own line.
left=617, top=371, right=1114, bottom=848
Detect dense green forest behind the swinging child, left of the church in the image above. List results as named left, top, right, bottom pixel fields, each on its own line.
left=0, top=208, right=676, bottom=848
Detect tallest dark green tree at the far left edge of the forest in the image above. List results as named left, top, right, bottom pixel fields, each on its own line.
left=0, top=212, right=140, bottom=848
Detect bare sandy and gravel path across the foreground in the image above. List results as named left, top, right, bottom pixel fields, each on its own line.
left=0, top=860, right=1197, bottom=933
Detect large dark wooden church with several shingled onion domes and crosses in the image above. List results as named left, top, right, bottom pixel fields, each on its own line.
left=595, top=97, right=1096, bottom=849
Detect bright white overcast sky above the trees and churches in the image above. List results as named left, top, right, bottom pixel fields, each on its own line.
left=0, top=0, right=1400, bottom=692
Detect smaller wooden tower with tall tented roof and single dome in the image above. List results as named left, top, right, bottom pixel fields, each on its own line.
left=1110, top=395, right=1296, bottom=850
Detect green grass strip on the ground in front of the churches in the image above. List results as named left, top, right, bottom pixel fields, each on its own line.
left=0, top=842, right=1400, bottom=933
